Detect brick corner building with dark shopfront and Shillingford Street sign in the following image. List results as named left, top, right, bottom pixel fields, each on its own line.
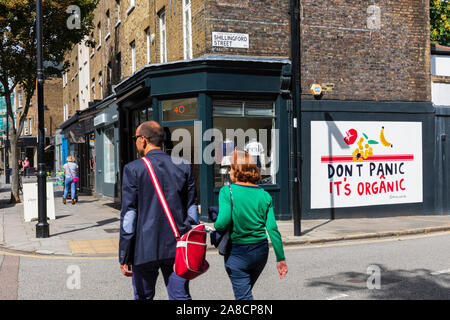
left=61, top=0, right=435, bottom=219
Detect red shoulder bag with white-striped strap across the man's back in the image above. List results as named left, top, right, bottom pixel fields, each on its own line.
left=142, top=157, right=209, bottom=280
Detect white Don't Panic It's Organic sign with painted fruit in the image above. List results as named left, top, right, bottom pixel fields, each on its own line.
left=311, top=121, right=423, bottom=209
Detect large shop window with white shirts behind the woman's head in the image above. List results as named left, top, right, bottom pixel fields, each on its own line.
left=213, top=99, right=278, bottom=187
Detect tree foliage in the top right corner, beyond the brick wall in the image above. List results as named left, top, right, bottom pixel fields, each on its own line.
left=430, top=0, right=450, bottom=46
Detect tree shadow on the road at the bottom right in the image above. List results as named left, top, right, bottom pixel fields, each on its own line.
left=307, top=264, right=450, bottom=300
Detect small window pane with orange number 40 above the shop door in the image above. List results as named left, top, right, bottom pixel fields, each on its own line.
left=161, top=98, right=197, bottom=121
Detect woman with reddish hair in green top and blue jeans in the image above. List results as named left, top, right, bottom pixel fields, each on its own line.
left=214, top=150, right=288, bottom=300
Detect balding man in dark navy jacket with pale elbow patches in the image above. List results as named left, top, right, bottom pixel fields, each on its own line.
left=119, top=121, right=198, bottom=300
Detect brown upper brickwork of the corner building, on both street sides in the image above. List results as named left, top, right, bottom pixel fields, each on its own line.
left=64, top=0, right=431, bottom=109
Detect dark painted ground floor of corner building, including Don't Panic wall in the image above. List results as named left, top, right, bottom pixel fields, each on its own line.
left=97, top=56, right=450, bottom=221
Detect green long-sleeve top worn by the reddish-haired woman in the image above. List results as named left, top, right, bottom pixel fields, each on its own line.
left=214, top=184, right=285, bottom=261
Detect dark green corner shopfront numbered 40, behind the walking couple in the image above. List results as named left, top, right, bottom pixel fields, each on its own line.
left=115, top=56, right=293, bottom=220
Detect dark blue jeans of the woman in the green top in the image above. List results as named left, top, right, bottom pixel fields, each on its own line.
left=225, top=240, right=269, bottom=300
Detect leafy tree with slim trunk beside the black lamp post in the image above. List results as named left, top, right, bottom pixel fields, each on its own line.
left=0, top=0, right=99, bottom=201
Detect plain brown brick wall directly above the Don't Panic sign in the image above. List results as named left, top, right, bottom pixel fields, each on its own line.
left=301, top=0, right=431, bottom=101
